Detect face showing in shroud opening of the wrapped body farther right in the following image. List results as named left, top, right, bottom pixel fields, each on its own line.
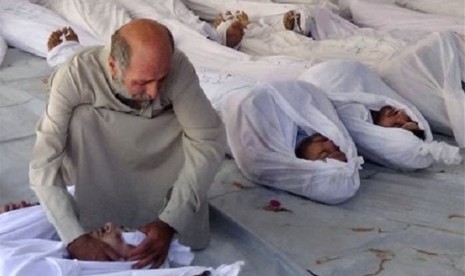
left=376, top=105, right=419, bottom=130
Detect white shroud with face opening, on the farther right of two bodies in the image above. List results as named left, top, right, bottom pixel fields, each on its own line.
left=300, top=61, right=461, bottom=170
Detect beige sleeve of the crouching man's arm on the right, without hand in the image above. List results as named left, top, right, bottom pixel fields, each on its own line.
left=159, top=52, right=225, bottom=243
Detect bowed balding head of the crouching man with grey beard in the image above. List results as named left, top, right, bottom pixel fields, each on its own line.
left=108, top=19, right=174, bottom=105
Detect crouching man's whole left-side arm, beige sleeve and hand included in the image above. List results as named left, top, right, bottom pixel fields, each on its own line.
left=29, top=66, right=120, bottom=260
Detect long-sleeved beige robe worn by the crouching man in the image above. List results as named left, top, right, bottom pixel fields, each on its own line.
left=29, top=46, right=224, bottom=248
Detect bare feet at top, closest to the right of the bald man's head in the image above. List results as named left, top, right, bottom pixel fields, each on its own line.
left=213, top=11, right=249, bottom=48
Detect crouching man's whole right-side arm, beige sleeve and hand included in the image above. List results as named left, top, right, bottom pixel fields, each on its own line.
left=129, top=51, right=225, bottom=268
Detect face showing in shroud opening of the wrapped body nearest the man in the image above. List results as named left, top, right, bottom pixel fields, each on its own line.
left=304, top=134, right=347, bottom=162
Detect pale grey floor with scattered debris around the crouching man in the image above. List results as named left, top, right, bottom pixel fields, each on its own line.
left=0, top=49, right=465, bottom=276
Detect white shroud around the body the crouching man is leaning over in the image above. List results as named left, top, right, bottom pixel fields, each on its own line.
left=0, top=205, right=243, bottom=276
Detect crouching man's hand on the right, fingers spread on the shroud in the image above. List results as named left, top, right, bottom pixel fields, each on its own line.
left=128, top=219, right=175, bottom=268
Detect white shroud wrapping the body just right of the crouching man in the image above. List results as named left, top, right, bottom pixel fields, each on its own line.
left=221, top=81, right=363, bottom=204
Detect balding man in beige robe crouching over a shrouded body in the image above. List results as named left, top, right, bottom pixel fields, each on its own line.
left=29, top=19, right=223, bottom=268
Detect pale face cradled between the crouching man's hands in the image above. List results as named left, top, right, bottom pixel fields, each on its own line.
left=90, top=222, right=134, bottom=258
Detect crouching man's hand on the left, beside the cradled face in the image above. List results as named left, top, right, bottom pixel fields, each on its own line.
left=68, top=233, right=122, bottom=261
